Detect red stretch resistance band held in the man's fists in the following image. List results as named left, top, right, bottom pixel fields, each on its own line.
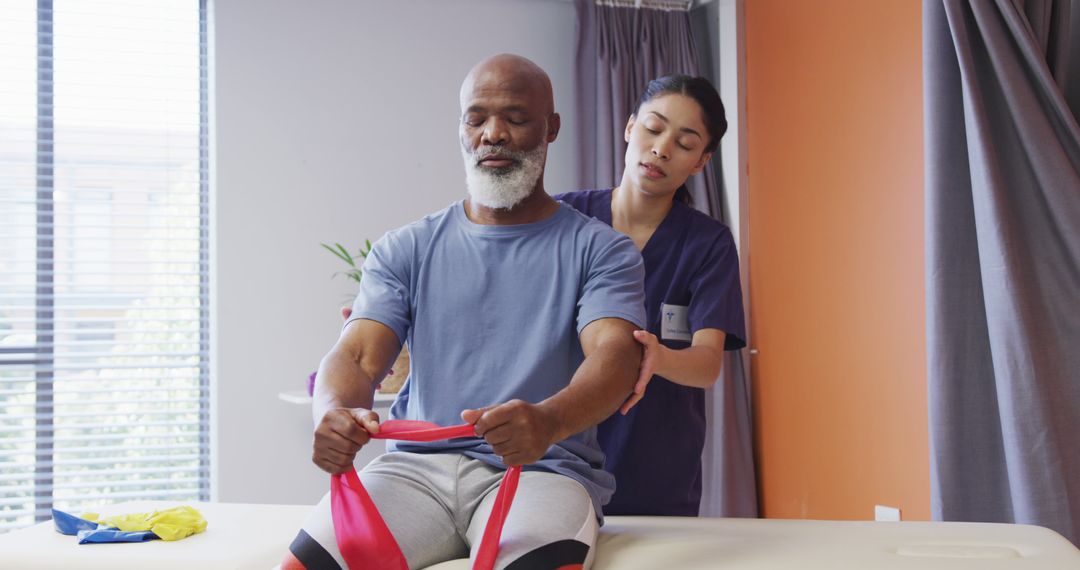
left=330, top=420, right=522, bottom=570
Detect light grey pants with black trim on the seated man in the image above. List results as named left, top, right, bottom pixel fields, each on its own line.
left=291, top=451, right=598, bottom=570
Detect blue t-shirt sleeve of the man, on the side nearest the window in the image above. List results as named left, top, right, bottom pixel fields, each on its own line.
left=346, top=229, right=413, bottom=343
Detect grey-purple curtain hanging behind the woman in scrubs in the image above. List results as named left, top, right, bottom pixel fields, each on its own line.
left=575, top=0, right=758, bottom=517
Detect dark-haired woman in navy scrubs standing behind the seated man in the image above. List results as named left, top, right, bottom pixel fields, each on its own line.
left=555, top=74, right=745, bottom=516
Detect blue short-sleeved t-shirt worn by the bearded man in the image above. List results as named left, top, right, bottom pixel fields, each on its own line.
left=350, top=201, right=645, bottom=514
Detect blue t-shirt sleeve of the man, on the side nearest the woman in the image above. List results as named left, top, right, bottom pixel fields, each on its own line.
left=577, top=231, right=646, bottom=335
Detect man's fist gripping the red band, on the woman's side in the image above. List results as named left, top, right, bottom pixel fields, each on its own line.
left=461, top=399, right=557, bottom=467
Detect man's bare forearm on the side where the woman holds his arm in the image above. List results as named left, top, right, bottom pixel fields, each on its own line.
left=539, top=337, right=642, bottom=442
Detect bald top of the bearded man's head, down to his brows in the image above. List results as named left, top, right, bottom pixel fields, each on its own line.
left=461, top=54, right=555, bottom=114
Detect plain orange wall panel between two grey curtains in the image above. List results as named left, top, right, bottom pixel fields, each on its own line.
left=745, top=0, right=930, bottom=519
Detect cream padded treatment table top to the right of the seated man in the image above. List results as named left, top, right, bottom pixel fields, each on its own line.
left=429, top=514, right=1080, bottom=570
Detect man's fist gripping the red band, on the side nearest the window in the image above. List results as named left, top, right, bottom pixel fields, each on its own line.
left=311, top=408, right=379, bottom=474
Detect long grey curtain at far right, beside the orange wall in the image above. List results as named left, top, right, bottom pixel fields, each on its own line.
left=923, top=0, right=1080, bottom=543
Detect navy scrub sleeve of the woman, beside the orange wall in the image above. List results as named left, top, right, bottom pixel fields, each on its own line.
left=689, top=228, right=746, bottom=350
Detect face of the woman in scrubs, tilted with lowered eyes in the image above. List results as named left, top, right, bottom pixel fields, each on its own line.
left=623, top=93, right=711, bottom=195
